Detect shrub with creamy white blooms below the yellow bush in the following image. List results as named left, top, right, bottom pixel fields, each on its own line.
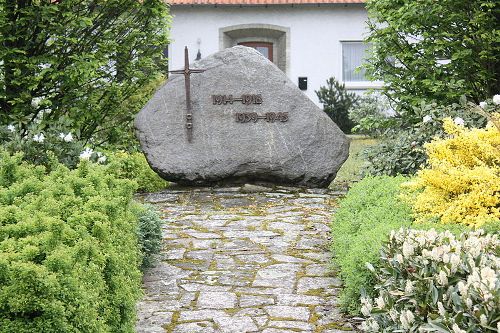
left=361, top=229, right=500, bottom=333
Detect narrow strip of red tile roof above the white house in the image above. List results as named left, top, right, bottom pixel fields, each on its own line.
left=167, top=0, right=366, bottom=6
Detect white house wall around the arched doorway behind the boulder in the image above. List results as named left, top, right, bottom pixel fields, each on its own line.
left=169, top=5, right=369, bottom=104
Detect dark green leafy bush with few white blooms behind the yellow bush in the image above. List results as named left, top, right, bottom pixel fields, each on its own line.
left=363, top=100, right=486, bottom=176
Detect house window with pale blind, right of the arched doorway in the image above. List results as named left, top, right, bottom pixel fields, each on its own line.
left=342, top=42, right=370, bottom=82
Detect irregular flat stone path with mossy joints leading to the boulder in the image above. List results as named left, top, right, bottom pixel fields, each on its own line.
left=137, top=188, right=351, bottom=333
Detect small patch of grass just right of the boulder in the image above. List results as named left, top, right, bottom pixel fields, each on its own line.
left=330, top=134, right=379, bottom=187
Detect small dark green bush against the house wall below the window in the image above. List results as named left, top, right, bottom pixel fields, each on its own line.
left=316, top=77, right=359, bottom=134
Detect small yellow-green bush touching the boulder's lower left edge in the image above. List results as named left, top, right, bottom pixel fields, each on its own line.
left=108, top=151, right=169, bottom=192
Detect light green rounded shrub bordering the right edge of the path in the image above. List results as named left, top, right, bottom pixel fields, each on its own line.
left=332, top=176, right=463, bottom=315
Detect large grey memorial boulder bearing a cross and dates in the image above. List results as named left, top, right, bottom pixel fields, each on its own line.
left=135, top=46, right=349, bottom=187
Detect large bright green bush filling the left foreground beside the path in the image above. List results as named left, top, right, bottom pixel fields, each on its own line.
left=0, top=152, right=141, bottom=333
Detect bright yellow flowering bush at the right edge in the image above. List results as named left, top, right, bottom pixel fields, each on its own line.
left=406, top=114, right=500, bottom=227
